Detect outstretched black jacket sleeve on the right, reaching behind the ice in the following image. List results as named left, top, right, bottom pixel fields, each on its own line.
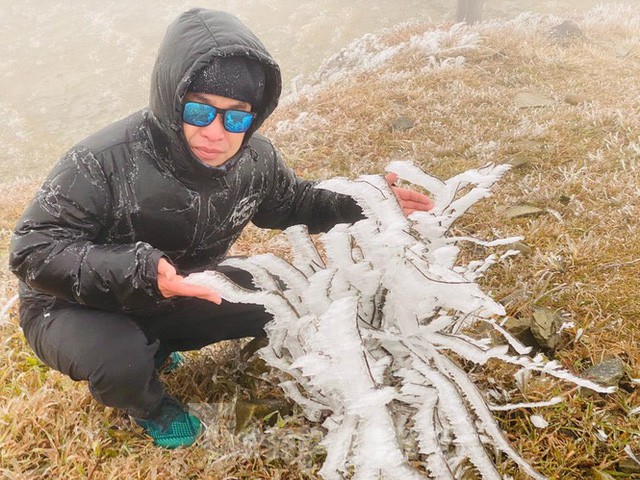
left=252, top=142, right=364, bottom=233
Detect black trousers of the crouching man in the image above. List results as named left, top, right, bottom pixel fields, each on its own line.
left=20, top=269, right=272, bottom=418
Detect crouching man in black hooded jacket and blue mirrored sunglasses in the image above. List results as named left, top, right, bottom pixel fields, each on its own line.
left=10, top=9, right=431, bottom=448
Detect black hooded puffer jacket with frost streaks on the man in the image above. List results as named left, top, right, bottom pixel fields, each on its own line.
left=9, top=9, right=361, bottom=313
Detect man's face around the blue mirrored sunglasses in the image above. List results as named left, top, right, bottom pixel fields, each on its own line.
left=182, top=93, right=251, bottom=167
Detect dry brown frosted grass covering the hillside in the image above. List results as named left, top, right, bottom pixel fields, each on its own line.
left=0, top=10, right=640, bottom=479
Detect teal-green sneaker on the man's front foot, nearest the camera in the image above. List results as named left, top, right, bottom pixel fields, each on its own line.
left=134, top=397, right=203, bottom=448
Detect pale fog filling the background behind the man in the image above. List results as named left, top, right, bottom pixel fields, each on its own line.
left=0, top=0, right=628, bottom=181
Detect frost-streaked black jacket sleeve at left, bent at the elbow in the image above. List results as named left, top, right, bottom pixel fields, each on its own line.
left=9, top=148, right=162, bottom=311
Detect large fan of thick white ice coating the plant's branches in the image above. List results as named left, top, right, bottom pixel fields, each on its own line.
left=188, top=162, right=611, bottom=480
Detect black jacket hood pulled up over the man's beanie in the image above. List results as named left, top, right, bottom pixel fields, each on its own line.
left=149, top=8, right=282, bottom=178
